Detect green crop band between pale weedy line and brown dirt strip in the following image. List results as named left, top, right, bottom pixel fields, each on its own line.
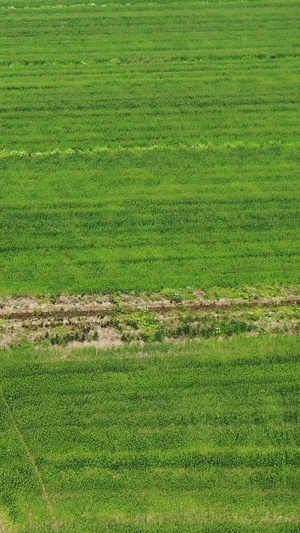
left=0, top=143, right=300, bottom=293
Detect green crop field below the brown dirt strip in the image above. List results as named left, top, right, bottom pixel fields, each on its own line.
left=0, top=337, right=300, bottom=533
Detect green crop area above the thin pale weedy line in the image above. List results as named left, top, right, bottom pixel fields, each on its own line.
left=0, top=0, right=299, bottom=151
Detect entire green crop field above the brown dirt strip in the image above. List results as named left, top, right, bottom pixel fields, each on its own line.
left=0, top=0, right=300, bottom=294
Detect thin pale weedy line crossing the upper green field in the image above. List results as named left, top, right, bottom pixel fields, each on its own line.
left=0, top=140, right=300, bottom=158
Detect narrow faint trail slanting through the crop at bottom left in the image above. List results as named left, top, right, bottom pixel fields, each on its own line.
left=0, top=386, right=59, bottom=533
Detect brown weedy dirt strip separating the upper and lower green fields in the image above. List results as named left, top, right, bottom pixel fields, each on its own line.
left=0, top=290, right=300, bottom=348
